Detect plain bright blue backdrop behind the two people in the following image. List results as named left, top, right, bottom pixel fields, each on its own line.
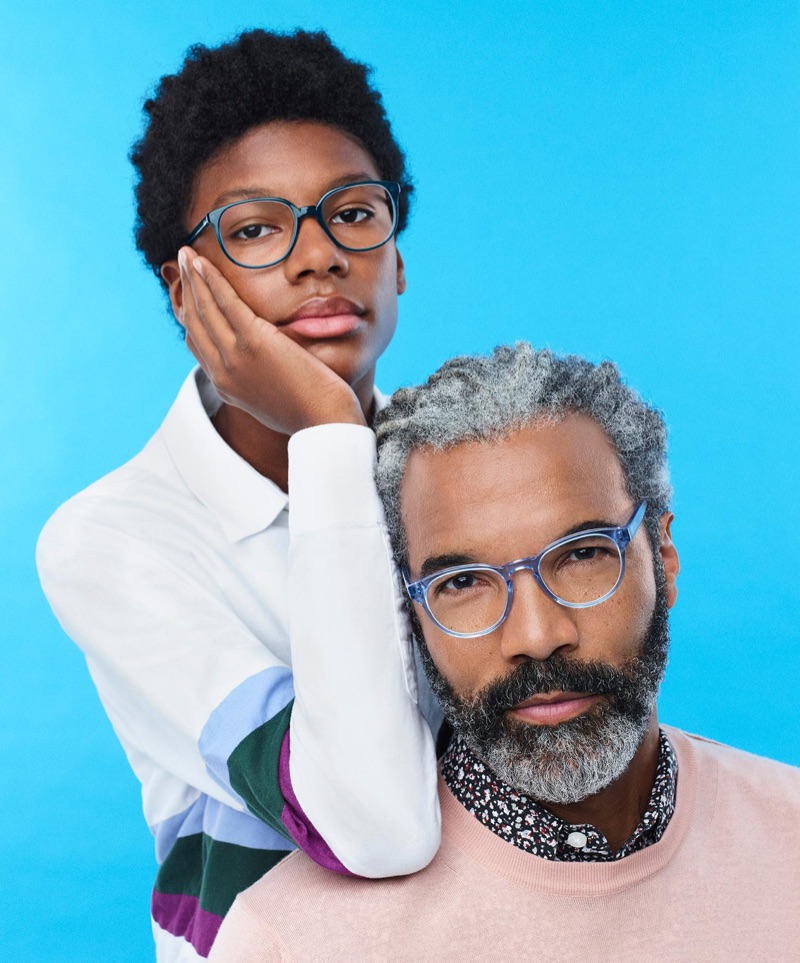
left=0, top=0, right=800, bottom=963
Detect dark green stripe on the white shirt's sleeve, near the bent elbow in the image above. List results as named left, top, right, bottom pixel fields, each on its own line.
left=228, top=699, right=294, bottom=839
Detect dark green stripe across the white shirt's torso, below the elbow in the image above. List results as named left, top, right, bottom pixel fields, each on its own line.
left=155, top=833, right=289, bottom=916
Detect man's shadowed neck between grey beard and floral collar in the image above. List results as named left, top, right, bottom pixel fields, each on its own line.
left=537, top=710, right=659, bottom=853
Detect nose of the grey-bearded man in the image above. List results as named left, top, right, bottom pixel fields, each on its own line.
left=499, top=570, right=579, bottom=662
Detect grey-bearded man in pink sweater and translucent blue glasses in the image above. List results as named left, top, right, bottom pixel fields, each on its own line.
left=211, top=344, right=800, bottom=963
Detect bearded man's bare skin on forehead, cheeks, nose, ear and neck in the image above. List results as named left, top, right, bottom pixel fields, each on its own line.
left=401, top=414, right=679, bottom=850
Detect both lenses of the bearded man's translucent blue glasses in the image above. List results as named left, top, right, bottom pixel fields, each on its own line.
left=427, top=535, right=622, bottom=635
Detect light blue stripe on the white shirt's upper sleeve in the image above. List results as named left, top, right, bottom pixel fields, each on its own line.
left=198, top=666, right=294, bottom=805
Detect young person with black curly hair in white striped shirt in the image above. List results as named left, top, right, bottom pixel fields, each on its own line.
left=38, top=30, right=439, bottom=963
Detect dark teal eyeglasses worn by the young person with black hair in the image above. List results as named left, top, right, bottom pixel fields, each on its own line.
left=185, top=181, right=400, bottom=268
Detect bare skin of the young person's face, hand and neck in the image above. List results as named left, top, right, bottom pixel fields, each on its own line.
left=161, top=122, right=405, bottom=490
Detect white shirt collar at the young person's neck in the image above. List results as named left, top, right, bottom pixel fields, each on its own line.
left=161, top=367, right=289, bottom=542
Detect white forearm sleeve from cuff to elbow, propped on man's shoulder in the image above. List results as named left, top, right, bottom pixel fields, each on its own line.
left=288, top=425, right=440, bottom=876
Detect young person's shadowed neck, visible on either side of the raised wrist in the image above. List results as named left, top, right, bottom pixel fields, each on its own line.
left=211, top=377, right=375, bottom=492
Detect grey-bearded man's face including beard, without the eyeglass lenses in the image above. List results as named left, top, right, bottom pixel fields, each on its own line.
left=401, top=414, right=678, bottom=803
